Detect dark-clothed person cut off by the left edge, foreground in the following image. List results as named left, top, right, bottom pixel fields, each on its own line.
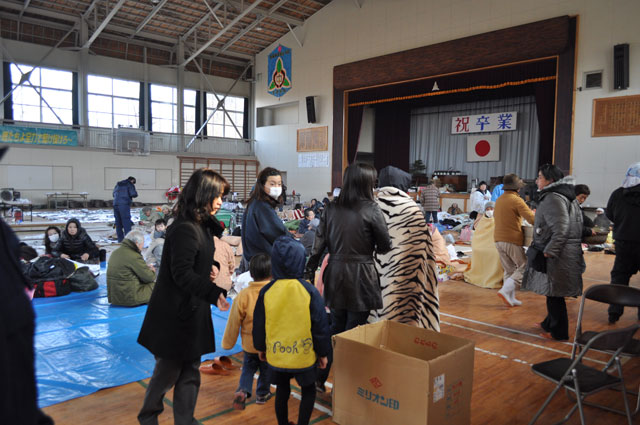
left=0, top=148, right=53, bottom=425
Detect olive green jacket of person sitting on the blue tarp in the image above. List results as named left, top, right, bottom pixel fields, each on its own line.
left=107, top=239, right=156, bottom=306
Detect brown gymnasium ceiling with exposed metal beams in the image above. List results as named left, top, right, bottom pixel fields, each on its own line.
left=0, top=0, right=331, bottom=78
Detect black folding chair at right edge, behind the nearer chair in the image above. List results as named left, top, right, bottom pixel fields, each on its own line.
left=571, top=284, right=640, bottom=416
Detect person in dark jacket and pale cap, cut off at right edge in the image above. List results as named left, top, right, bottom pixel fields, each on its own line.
left=607, top=162, right=640, bottom=323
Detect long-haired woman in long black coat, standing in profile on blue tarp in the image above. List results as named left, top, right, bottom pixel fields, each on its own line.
left=138, top=168, right=229, bottom=425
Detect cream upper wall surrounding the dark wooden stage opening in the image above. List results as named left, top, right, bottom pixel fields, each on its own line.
left=254, top=0, right=640, bottom=205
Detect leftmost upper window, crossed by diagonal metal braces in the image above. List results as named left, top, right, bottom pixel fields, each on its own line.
left=11, top=64, right=73, bottom=125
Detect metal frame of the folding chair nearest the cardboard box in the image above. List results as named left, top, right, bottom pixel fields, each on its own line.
left=529, top=324, right=640, bottom=425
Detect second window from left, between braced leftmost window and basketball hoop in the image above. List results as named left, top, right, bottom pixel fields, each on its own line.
left=87, top=75, right=140, bottom=128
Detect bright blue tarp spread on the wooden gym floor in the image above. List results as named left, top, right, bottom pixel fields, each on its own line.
left=33, top=273, right=242, bottom=407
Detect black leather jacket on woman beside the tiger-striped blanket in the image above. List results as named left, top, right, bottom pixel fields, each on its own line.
left=305, top=201, right=391, bottom=311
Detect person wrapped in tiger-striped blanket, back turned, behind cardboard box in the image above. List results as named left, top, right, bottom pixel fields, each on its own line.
left=369, top=166, right=440, bottom=331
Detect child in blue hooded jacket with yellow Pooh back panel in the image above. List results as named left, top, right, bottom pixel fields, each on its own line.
left=253, top=236, right=331, bottom=425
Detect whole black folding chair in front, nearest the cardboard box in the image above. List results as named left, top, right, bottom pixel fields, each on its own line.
left=529, top=324, right=640, bottom=425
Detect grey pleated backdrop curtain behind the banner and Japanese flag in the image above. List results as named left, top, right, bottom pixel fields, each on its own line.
left=410, top=96, right=540, bottom=182
